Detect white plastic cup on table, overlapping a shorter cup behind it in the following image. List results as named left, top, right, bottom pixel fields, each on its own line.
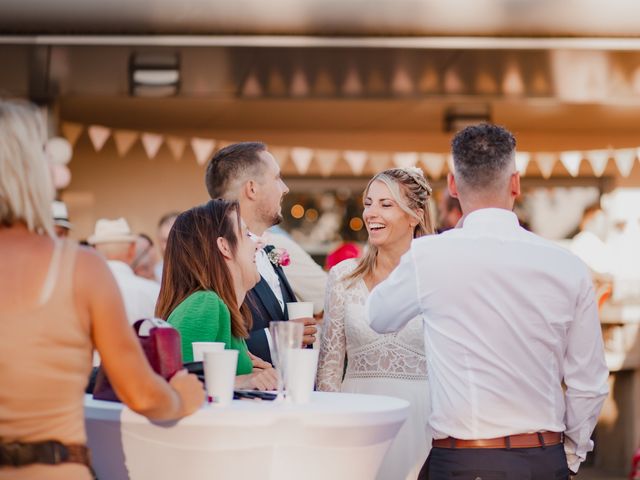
left=204, top=350, right=238, bottom=407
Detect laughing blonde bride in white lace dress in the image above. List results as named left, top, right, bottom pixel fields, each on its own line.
left=317, top=167, right=433, bottom=480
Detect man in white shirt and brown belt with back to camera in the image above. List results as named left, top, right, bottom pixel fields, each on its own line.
left=367, top=124, right=608, bottom=480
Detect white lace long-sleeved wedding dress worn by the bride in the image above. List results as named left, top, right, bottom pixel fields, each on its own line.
left=317, top=259, right=431, bottom=480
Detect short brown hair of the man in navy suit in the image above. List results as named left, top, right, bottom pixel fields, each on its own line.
left=205, top=142, right=267, bottom=198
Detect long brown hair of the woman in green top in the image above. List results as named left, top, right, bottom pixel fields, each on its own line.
left=156, top=200, right=252, bottom=338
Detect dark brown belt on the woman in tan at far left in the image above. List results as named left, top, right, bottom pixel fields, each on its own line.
left=0, top=440, right=91, bottom=468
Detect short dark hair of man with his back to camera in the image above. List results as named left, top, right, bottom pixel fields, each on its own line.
left=451, top=123, right=516, bottom=189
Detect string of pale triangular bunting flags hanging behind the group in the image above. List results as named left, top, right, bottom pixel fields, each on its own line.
left=62, top=122, right=640, bottom=180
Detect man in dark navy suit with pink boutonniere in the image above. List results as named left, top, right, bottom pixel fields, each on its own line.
left=205, top=142, right=317, bottom=362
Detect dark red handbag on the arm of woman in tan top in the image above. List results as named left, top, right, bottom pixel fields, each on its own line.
left=93, top=318, right=182, bottom=402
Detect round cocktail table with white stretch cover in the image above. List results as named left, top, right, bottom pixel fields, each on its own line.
left=85, top=392, right=409, bottom=480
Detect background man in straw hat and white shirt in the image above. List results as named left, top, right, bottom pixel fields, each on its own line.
left=88, top=218, right=160, bottom=324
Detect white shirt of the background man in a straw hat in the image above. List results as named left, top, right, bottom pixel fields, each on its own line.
left=107, top=260, right=160, bottom=324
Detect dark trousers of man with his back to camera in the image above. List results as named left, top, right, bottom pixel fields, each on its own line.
left=418, top=444, right=569, bottom=480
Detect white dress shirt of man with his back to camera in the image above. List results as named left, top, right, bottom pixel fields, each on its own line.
left=367, top=209, right=609, bottom=471
